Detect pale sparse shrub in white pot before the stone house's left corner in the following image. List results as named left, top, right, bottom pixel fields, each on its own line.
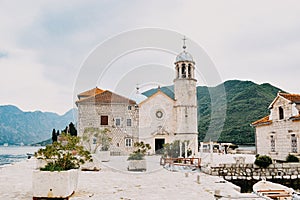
left=82, top=127, right=112, bottom=162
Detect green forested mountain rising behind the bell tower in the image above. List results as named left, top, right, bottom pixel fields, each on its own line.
left=143, top=80, right=282, bottom=144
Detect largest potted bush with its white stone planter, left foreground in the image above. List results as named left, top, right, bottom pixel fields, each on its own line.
left=32, top=134, right=92, bottom=199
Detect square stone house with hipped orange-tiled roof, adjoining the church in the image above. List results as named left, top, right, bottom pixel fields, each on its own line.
left=76, top=87, right=139, bottom=155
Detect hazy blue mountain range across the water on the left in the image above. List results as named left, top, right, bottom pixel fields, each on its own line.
left=0, top=105, right=77, bottom=145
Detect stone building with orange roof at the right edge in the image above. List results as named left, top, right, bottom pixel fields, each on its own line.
left=252, top=92, right=300, bottom=160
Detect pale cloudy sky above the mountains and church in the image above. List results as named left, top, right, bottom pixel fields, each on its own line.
left=0, top=0, right=300, bottom=114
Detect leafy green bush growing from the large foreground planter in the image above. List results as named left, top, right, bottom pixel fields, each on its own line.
left=35, top=134, right=92, bottom=171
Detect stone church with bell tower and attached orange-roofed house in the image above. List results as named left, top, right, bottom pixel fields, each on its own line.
left=76, top=45, right=198, bottom=155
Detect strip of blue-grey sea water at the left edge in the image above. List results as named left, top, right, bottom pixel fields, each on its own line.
left=0, top=146, right=41, bottom=166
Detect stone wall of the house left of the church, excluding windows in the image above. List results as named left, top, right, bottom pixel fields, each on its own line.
left=78, top=103, right=139, bottom=155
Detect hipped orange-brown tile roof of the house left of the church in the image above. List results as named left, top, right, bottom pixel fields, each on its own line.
left=76, top=90, right=136, bottom=104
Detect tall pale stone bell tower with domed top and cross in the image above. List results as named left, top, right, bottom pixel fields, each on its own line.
left=174, top=37, right=198, bottom=153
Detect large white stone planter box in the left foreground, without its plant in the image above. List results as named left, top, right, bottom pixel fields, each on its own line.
left=32, top=169, right=78, bottom=199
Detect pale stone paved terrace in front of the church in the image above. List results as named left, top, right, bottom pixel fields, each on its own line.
left=0, top=156, right=260, bottom=200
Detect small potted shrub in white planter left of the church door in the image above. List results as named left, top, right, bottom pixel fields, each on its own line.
left=127, top=142, right=151, bottom=171
